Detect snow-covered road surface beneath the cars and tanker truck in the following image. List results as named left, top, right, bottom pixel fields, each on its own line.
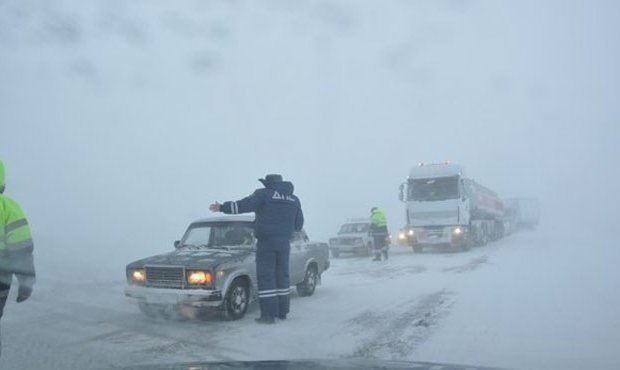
left=0, top=230, right=620, bottom=370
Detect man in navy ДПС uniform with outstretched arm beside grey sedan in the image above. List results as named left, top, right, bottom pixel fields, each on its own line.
left=209, top=174, right=304, bottom=324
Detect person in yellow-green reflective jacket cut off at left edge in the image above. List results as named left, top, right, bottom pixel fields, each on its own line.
left=0, top=160, right=35, bottom=353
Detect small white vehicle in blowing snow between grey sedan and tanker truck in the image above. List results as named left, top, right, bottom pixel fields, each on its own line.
left=329, top=218, right=375, bottom=257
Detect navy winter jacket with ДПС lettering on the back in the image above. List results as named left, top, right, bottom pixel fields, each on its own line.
left=220, top=181, right=304, bottom=240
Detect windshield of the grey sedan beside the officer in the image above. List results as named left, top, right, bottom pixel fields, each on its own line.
left=182, top=222, right=254, bottom=247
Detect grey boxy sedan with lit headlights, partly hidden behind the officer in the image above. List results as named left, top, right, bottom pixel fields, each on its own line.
left=125, top=216, right=329, bottom=320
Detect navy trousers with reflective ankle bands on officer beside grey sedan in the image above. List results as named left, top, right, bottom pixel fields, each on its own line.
left=256, top=238, right=291, bottom=317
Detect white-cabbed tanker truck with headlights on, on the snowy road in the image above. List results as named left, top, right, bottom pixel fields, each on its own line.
left=398, top=162, right=504, bottom=252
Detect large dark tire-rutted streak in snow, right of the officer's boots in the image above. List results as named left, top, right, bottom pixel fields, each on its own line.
left=345, top=290, right=453, bottom=360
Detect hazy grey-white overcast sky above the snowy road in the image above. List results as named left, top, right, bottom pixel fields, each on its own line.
left=0, top=0, right=620, bottom=268
